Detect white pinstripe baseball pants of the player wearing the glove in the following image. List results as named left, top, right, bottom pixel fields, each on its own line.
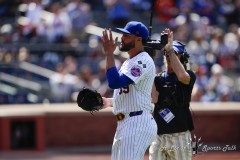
left=112, top=112, right=157, bottom=160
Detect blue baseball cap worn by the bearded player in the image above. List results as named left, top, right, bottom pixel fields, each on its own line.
left=116, top=21, right=148, bottom=40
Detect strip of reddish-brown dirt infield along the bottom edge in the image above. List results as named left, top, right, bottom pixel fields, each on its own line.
left=0, top=151, right=240, bottom=160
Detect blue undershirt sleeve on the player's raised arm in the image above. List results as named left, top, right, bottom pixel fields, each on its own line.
left=106, top=67, right=134, bottom=89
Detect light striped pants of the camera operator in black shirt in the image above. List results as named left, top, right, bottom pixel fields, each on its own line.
left=149, top=131, right=192, bottom=160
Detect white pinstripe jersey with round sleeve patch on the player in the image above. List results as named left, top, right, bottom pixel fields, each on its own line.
left=113, top=52, right=156, bottom=114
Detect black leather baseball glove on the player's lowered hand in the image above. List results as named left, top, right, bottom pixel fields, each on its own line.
left=77, top=87, right=103, bottom=113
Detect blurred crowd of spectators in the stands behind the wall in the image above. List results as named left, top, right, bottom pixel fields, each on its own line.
left=0, top=0, right=240, bottom=104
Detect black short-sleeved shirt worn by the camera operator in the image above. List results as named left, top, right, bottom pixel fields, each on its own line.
left=154, top=70, right=196, bottom=134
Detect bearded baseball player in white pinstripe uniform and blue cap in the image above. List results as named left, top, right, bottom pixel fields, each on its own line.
left=102, top=21, right=157, bottom=160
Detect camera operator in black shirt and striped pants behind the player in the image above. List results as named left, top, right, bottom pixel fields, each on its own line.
left=149, top=29, right=196, bottom=160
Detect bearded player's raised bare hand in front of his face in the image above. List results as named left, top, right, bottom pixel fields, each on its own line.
left=102, top=29, right=118, bottom=55
